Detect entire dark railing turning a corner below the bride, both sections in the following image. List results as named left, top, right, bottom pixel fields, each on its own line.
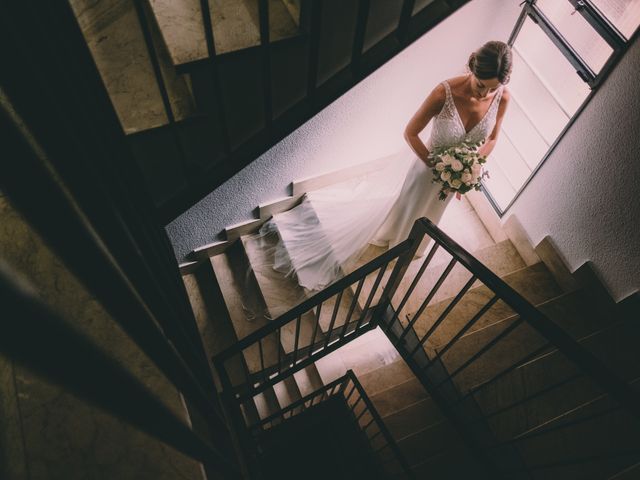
left=216, top=219, right=640, bottom=478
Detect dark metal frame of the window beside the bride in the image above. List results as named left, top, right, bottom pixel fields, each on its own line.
left=482, top=0, right=640, bottom=218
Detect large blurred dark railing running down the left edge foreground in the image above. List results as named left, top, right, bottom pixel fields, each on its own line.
left=0, top=0, right=239, bottom=477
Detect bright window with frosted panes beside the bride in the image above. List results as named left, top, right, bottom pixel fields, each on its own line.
left=483, top=0, right=640, bottom=215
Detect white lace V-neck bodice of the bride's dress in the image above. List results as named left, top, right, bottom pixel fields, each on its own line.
left=427, top=81, right=504, bottom=151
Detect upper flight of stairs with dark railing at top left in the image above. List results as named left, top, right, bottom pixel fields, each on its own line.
left=70, top=0, right=468, bottom=224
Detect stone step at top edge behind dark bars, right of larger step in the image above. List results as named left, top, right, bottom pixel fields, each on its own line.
left=150, top=0, right=298, bottom=66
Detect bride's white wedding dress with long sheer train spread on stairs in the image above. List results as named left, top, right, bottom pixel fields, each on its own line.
left=259, top=81, right=503, bottom=291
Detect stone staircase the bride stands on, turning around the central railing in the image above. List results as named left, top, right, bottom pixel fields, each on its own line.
left=183, top=163, right=640, bottom=479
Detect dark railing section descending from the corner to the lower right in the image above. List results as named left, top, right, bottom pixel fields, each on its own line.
left=379, top=219, right=640, bottom=478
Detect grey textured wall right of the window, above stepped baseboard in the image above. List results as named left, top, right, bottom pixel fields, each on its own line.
left=506, top=40, right=640, bottom=300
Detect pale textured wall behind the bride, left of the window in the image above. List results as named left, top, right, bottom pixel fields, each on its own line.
left=167, top=0, right=520, bottom=261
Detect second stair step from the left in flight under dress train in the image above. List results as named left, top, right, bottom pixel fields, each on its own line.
left=210, top=242, right=279, bottom=372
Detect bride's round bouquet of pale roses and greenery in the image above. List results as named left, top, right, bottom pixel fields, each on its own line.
left=429, top=142, right=489, bottom=200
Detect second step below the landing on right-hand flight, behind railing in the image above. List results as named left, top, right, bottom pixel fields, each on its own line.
left=408, top=263, right=563, bottom=348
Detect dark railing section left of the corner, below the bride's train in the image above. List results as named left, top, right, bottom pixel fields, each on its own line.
left=214, top=242, right=409, bottom=402
